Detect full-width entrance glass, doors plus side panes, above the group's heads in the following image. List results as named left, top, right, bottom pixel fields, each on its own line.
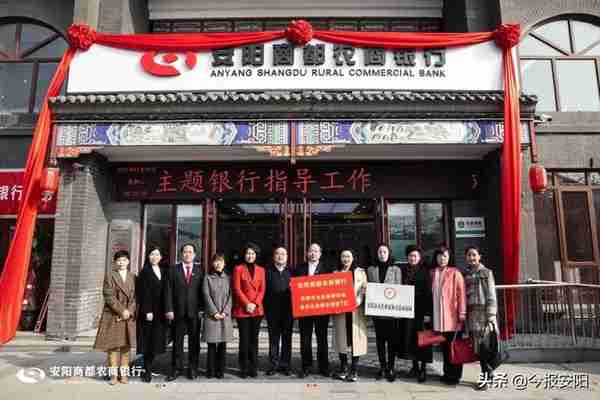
left=142, top=198, right=449, bottom=268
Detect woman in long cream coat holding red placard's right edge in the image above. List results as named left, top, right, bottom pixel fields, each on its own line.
left=333, top=249, right=368, bottom=382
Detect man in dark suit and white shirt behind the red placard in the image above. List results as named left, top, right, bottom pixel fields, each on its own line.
left=294, top=243, right=331, bottom=378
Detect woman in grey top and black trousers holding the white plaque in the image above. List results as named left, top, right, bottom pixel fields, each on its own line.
left=367, top=244, right=402, bottom=382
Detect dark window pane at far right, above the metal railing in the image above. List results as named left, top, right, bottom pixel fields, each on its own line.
left=561, top=191, right=594, bottom=261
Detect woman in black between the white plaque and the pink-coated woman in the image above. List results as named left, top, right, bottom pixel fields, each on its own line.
left=399, top=246, right=433, bottom=382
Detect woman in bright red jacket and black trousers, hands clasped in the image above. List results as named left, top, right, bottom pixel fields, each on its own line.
left=232, top=243, right=266, bottom=379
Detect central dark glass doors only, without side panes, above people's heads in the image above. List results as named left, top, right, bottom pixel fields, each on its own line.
left=214, top=199, right=377, bottom=267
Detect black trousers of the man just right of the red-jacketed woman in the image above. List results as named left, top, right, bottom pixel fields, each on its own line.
left=267, top=308, right=294, bottom=368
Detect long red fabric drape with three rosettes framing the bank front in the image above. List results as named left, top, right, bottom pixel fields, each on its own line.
left=0, top=21, right=521, bottom=343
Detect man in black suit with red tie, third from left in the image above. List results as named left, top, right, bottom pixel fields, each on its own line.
left=165, top=243, right=204, bottom=381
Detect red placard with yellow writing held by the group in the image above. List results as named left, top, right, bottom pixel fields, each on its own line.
left=290, top=272, right=356, bottom=318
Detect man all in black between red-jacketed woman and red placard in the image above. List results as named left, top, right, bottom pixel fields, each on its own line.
left=263, top=246, right=294, bottom=376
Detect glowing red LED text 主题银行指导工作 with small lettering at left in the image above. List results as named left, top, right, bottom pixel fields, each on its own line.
left=115, top=166, right=375, bottom=200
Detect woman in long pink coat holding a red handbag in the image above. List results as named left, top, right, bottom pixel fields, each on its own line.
left=431, top=246, right=467, bottom=385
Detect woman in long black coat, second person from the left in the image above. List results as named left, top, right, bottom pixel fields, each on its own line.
left=137, top=247, right=168, bottom=382
